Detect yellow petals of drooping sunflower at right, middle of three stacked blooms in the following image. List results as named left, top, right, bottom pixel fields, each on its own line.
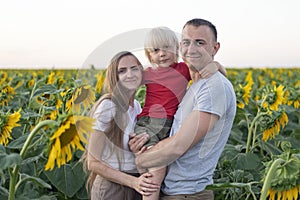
left=262, top=112, right=289, bottom=141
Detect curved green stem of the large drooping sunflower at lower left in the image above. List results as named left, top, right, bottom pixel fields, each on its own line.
left=8, top=120, right=57, bottom=200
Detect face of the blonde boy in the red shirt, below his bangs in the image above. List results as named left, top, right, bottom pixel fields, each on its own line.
left=149, top=45, right=177, bottom=67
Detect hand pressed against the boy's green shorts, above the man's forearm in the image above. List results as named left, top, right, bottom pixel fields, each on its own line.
left=128, top=133, right=149, bottom=156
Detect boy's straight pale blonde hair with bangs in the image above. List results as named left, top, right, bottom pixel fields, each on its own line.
left=144, top=26, right=179, bottom=62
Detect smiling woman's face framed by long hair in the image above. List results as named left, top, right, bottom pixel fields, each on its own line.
left=118, top=55, right=142, bottom=90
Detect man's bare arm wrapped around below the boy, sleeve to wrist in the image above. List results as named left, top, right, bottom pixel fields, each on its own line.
left=136, top=111, right=219, bottom=168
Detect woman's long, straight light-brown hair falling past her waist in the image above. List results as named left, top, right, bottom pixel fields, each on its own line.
left=81, top=51, right=143, bottom=192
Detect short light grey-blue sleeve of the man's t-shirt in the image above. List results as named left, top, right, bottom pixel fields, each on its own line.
left=194, top=76, right=226, bottom=117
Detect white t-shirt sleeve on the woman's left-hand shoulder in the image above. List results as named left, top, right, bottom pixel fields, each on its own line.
left=93, top=99, right=116, bottom=132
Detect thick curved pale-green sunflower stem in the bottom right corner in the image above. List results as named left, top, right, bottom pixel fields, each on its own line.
left=260, top=158, right=285, bottom=200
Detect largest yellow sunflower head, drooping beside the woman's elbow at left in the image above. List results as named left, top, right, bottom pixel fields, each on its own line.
left=45, top=115, right=94, bottom=170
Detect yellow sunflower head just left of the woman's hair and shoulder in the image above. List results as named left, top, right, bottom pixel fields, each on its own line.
left=71, top=85, right=95, bottom=113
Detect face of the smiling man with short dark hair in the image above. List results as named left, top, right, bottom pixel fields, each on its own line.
left=180, top=25, right=220, bottom=69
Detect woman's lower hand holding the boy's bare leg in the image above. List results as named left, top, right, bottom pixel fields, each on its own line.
left=133, top=172, right=160, bottom=196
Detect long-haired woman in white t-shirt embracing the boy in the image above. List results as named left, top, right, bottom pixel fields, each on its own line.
left=86, top=52, right=159, bottom=200
